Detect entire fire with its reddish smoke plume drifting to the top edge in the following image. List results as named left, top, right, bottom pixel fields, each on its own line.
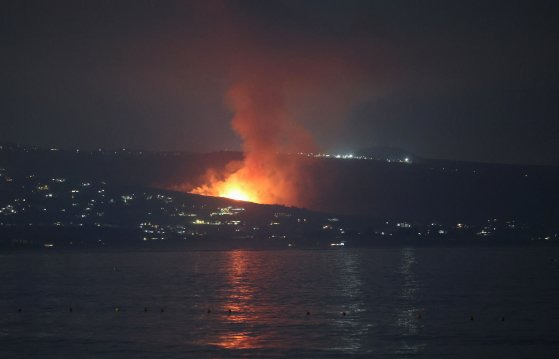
left=191, top=1, right=384, bottom=207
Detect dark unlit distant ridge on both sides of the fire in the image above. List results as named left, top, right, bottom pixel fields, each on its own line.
left=0, top=146, right=559, bottom=224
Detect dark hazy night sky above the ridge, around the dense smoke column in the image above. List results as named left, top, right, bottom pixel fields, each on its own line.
left=0, top=0, right=559, bottom=165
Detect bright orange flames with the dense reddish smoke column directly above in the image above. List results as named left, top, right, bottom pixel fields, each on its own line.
left=192, top=77, right=314, bottom=206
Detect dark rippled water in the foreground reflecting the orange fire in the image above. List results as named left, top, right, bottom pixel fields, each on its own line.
left=0, top=247, right=559, bottom=358
